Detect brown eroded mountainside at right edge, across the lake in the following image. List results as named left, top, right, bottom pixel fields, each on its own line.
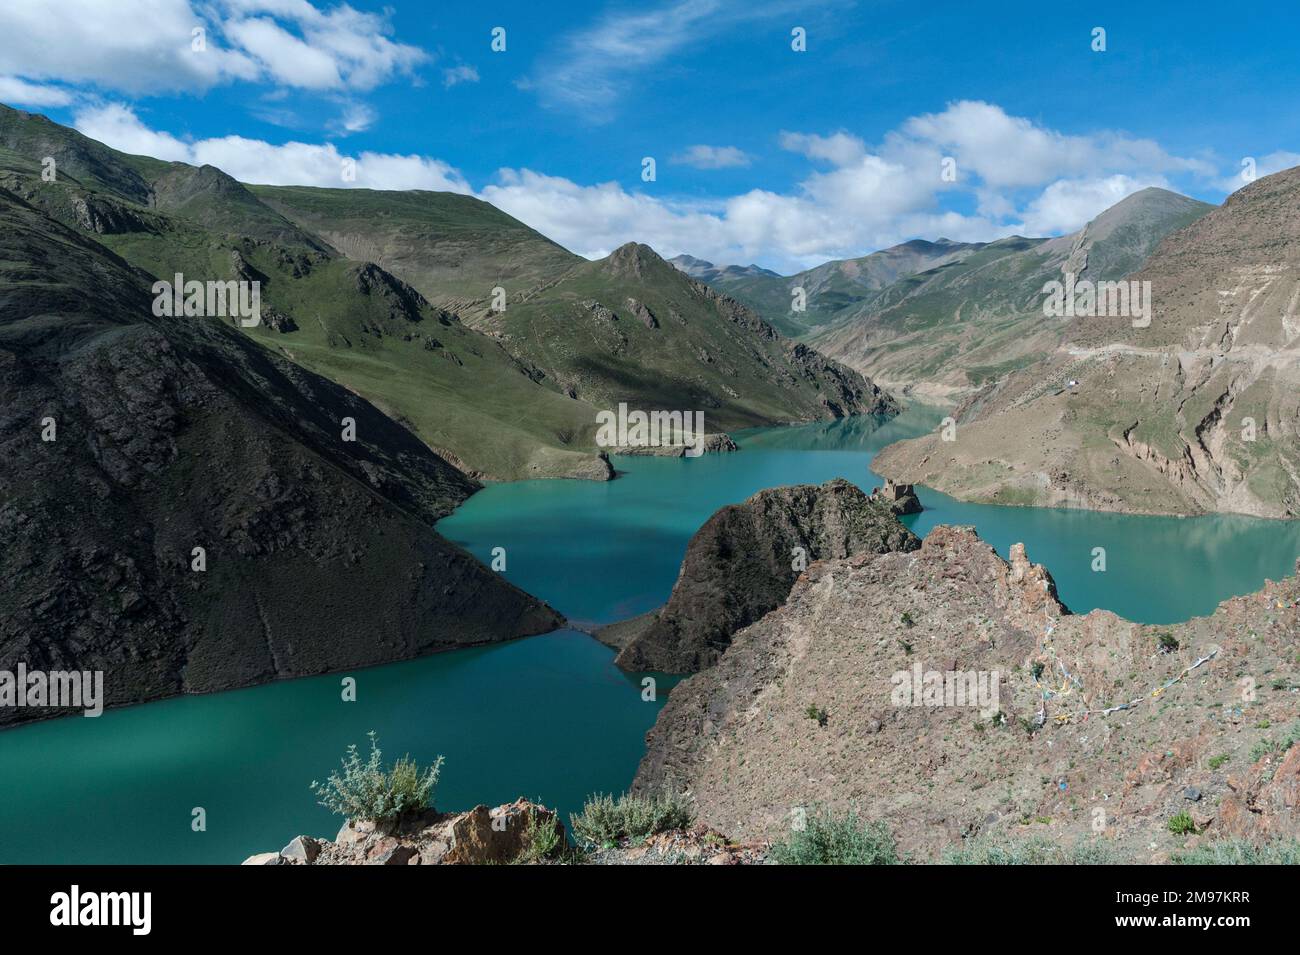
left=875, top=169, right=1300, bottom=517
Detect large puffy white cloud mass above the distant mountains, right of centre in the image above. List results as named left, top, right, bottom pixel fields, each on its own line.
left=482, top=101, right=1212, bottom=270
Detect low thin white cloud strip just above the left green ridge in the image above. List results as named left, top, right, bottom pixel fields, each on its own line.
left=74, top=104, right=471, bottom=194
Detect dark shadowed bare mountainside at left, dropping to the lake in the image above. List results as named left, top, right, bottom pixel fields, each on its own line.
left=0, top=191, right=560, bottom=725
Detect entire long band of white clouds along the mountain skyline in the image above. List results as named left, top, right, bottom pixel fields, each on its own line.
left=65, top=98, right=1211, bottom=272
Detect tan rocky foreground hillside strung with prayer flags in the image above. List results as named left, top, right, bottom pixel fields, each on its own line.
left=636, top=526, right=1300, bottom=861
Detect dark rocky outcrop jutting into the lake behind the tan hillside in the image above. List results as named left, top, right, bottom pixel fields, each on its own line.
left=597, top=479, right=920, bottom=673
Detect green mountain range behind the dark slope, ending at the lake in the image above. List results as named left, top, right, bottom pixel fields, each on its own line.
left=0, top=108, right=892, bottom=479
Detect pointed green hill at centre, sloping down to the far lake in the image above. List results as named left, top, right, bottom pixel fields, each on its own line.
left=476, top=243, right=896, bottom=431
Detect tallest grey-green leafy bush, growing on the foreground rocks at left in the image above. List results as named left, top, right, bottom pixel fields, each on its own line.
left=312, top=732, right=442, bottom=822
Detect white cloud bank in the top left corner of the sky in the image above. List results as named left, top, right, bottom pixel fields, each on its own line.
left=0, top=0, right=428, bottom=94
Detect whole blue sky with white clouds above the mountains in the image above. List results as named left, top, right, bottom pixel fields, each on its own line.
left=0, top=0, right=1300, bottom=272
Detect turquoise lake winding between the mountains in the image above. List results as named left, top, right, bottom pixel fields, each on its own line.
left=0, top=409, right=1300, bottom=863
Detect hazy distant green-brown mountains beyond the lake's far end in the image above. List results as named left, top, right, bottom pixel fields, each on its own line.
left=676, top=188, right=1213, bottom=401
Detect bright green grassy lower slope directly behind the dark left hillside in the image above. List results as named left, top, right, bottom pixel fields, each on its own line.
left=103, top=223, right=607, bottom=479
